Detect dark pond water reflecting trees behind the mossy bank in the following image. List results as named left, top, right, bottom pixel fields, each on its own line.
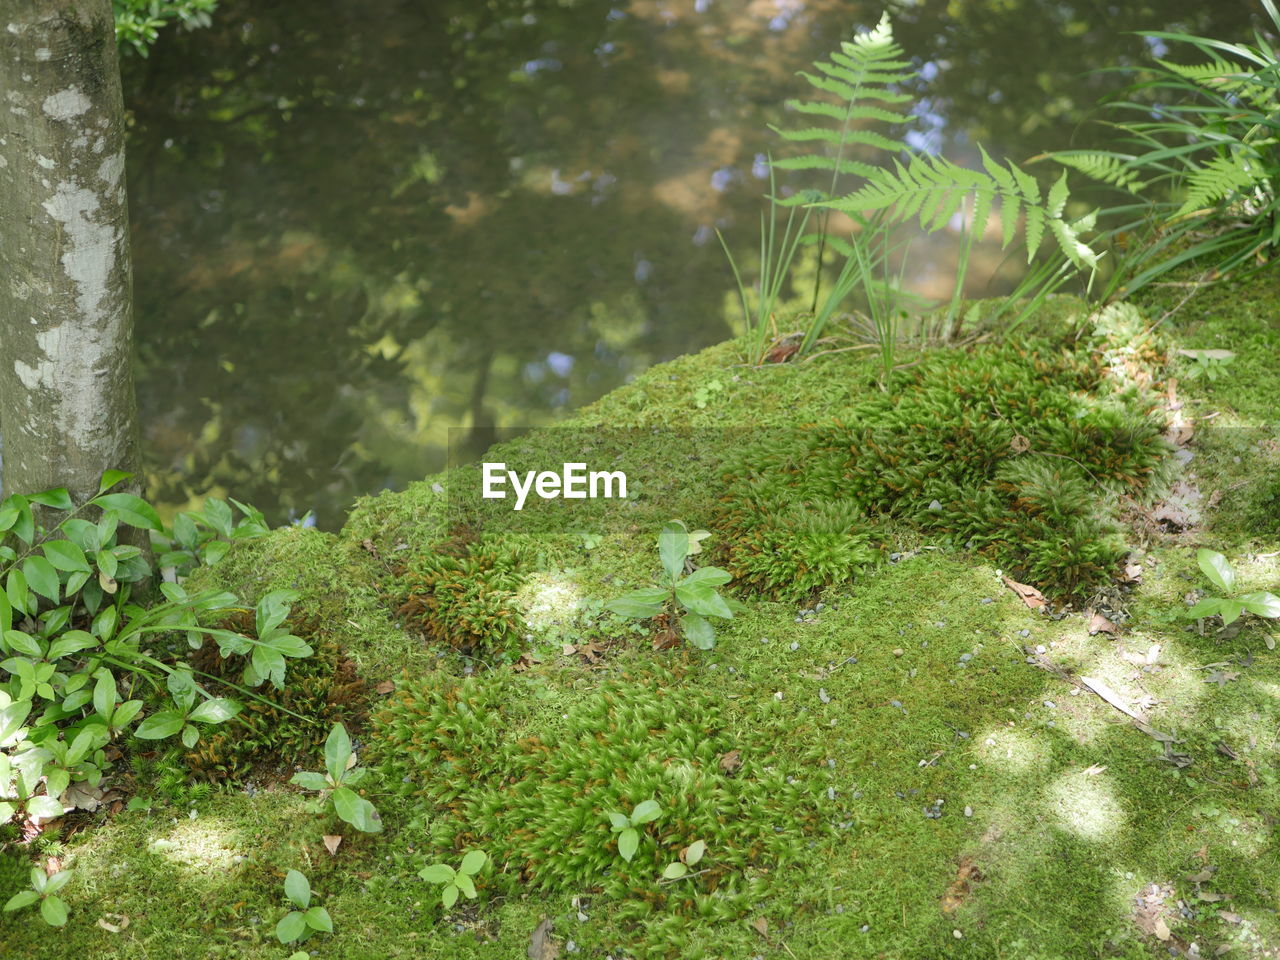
left=124, top=0, right=1252, bottom=527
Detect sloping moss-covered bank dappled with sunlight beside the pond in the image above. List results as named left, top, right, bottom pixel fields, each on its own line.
left=0, top=279, right=1280, bottom=960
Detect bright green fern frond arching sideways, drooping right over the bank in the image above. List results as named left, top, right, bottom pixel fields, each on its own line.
left=823, top=146, right=1098, bottom=270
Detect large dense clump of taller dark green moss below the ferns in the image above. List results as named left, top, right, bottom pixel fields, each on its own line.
left=719, top=337, right=1166, bottom=598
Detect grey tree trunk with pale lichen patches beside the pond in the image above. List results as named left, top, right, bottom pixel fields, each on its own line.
left=0, top=0, right=138, bottom=503
